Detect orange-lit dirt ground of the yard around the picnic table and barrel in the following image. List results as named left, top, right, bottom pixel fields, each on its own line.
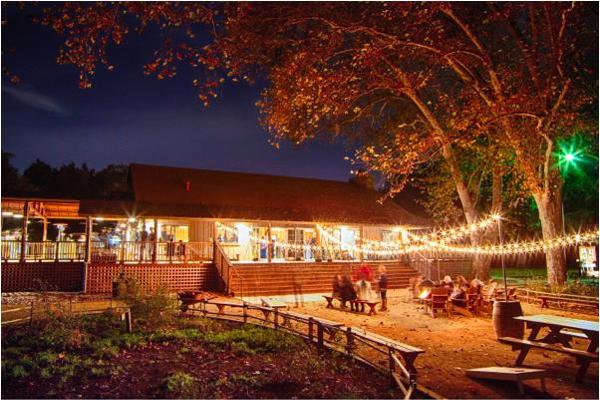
left=294, top=289, right=598, bottom=399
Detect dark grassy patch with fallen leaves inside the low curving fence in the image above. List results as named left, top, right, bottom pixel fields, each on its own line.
left=2, top=297, right=398, bottom=398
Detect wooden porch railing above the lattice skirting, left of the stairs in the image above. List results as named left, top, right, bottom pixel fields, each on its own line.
left=0, top=240, right=213, bottom=263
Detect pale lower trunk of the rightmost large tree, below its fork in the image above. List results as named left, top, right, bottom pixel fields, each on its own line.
left=533, top=190, right=567, bottom=285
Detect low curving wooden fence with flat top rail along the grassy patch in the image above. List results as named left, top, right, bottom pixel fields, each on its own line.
left=188, top=300, right=432, bottom=399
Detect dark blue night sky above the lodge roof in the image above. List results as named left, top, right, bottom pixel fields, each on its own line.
left=2, top=2, right=350, bottom=180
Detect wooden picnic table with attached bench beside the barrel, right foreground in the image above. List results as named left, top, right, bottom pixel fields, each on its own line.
left=499, top=315, right=598, bottom=382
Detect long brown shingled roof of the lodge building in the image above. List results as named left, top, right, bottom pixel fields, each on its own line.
left=96, top=164, right=427, bottom=226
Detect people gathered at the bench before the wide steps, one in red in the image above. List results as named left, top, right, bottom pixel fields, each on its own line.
left=332, top=265, right=388, bottom=312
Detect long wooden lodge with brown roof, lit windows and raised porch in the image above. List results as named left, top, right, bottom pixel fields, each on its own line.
left=1, top=164, right=464, bottom=297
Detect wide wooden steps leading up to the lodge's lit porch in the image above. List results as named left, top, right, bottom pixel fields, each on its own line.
left=225, top=262, right=417, bottom=297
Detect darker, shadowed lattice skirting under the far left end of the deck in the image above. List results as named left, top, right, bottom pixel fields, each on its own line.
left=2, top=262, right=83, bottom=292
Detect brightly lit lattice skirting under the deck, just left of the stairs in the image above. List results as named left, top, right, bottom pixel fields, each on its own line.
left=86, top=263, right=217, bottom=293
